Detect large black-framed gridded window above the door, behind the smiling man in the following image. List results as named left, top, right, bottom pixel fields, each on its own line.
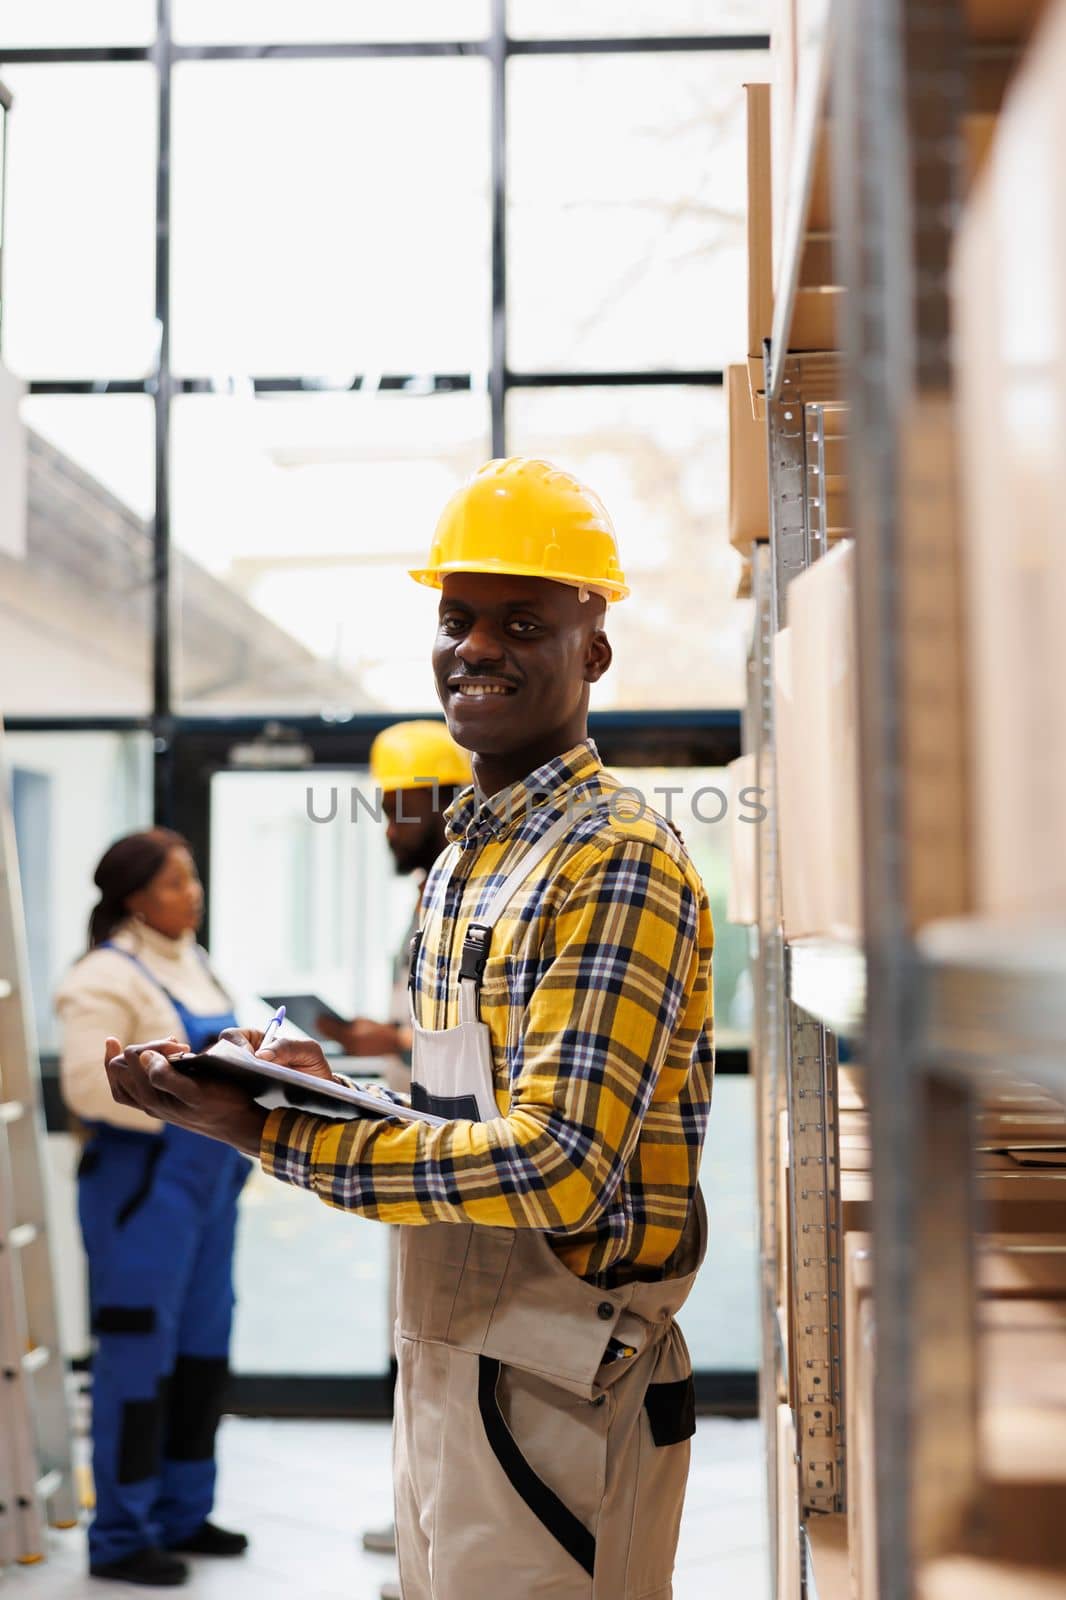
left=0, top=9, right=767, bottom=723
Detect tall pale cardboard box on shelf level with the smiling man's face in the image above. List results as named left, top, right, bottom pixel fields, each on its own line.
left=775, top=544, right=863, bottom=939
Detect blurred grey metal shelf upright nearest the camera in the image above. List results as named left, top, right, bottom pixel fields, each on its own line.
left=832, top=0, right=976, bottom=1600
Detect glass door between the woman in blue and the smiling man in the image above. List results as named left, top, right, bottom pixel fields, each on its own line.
left=208, top=768, right=415, bottom=1413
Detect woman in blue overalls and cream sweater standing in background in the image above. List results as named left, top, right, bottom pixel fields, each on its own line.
left=56, top=829, right=248, bottom=1587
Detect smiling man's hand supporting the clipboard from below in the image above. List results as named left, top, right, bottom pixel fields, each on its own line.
left=104, top=1038, right=269, bottom=1157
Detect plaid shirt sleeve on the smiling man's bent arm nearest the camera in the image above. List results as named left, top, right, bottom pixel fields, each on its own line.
left=261, top=835, right=701, bottom=1234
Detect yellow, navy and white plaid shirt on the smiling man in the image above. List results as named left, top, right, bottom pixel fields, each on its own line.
left=261, top=742, right=714, bottom=1286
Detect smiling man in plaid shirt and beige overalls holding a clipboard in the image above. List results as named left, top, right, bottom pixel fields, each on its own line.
left=109, top=459, right=714, bottom=1600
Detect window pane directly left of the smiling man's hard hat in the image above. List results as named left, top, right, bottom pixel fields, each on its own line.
left=171, top=392, right=488, bottom=712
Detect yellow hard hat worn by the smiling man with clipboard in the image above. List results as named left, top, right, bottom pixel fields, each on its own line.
left=404, top=456, right=629, bottom=600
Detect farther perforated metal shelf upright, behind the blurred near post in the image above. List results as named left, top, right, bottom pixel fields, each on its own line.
left=746, top=350, right=845, bottom=1587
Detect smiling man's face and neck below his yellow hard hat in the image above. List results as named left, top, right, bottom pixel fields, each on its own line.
left=434, top=573, right=611, bottom=794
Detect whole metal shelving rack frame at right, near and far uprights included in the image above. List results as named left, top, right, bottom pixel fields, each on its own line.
left=746, top=0, right=1066, bottom=1600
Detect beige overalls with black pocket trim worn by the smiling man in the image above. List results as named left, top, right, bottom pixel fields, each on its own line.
left=394, top=818, right=706, bottom=1600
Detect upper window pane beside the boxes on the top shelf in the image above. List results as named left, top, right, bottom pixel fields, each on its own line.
left=507, top=51, right=762, bottom=371
